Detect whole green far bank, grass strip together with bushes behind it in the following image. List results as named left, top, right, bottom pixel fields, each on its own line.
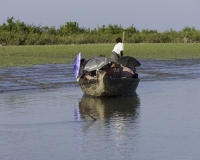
left=0, top=17, right=200, bottom=68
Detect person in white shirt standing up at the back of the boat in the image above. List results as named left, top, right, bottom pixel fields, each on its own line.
left=110, top=37, right=124, bottom=64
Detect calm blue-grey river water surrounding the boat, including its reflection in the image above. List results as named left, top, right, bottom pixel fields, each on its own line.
left=0, top=59, right=200, bottom=160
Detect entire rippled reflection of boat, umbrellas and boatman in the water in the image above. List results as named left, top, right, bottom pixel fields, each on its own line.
left=75, top=95, right=140, bottom=152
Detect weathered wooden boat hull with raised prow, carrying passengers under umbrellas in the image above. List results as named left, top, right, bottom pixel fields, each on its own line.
left=79, top=70, right=140, bottom=96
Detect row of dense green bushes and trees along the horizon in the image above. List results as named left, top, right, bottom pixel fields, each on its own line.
left=0, top=17, right=200, bottom=45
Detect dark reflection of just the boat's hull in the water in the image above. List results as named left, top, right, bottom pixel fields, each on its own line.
left=78, top=95, right=140, bottom=121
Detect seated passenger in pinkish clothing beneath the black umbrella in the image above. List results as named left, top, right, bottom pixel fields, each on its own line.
left=117, top=65, right=138, bottom=78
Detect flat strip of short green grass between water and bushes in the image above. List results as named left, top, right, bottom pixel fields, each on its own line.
left=0, top=43, right=200, bottom=68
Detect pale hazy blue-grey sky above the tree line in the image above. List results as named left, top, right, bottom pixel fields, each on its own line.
left=0, top=0, right=200, bottom=32
